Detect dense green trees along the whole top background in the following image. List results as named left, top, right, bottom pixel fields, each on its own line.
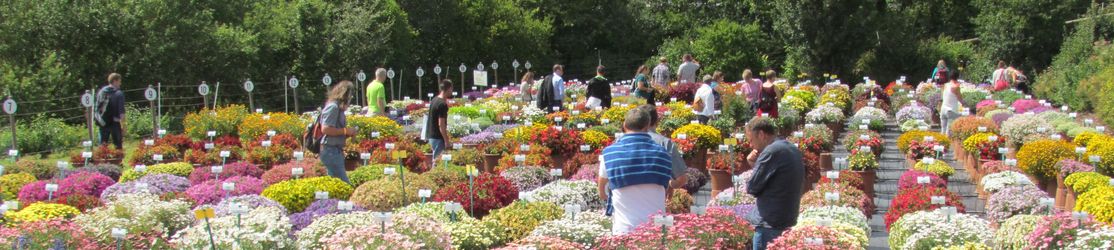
left=0, top=0, right=1107, bottom=116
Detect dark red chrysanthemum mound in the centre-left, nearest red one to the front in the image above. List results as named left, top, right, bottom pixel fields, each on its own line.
left=433, top=173, right=518, bottom=218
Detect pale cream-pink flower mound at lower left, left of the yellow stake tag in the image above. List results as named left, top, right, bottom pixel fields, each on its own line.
left=74, top=193, right=194, bottom=241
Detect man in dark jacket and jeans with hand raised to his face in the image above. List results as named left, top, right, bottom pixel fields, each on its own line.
left=745, top=116, right=804, bottom=250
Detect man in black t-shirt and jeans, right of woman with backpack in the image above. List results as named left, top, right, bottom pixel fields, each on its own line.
left=424, top=79, right=452, bottom=165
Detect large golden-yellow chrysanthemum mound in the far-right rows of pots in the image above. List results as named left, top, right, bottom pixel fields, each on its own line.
left=1017, top=140, right=1075, bottom=180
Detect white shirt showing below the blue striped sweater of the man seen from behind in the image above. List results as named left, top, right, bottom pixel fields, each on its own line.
left=599, top=156, right=665, bottom=235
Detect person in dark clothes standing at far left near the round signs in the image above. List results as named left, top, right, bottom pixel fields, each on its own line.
left=94, top=73, right=125, bottom=150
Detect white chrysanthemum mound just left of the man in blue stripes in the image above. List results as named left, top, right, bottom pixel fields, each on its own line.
left=527, top=180, right=604, bottom=210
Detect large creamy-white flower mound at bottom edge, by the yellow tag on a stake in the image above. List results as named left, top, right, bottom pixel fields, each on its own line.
left=170, top=206, right=294, bottom=249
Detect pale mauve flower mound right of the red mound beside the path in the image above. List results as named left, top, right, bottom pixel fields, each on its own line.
left=986, top=185, right=1051, bottom=223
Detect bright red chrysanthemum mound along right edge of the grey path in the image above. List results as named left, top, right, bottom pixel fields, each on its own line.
left=886, top=188, right=966, bottom=230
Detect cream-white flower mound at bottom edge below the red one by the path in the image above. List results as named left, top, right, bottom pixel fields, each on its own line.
left=890, top=209, right=994, bottom=250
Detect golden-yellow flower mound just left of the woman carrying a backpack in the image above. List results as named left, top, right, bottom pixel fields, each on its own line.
left=240, top=113, right=312, bottom=142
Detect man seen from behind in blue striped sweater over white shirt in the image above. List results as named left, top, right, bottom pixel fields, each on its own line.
left=597, top=108, right=674, bottom=235
